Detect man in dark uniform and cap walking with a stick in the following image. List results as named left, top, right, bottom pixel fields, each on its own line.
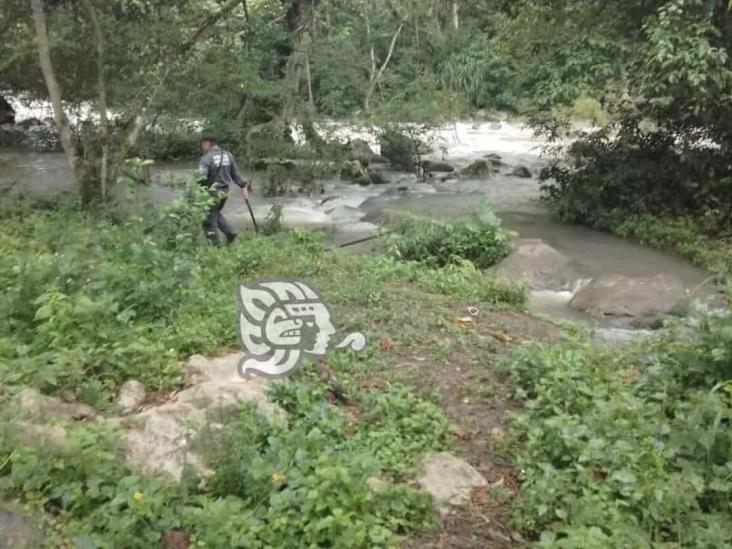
left=198, top=133, right=249, bottom=246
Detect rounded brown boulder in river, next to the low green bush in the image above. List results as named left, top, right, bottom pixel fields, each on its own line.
left=492, top=238, right=583, bottom=291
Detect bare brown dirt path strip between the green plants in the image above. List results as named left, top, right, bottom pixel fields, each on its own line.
left=400, top=310, right=560, bottom=549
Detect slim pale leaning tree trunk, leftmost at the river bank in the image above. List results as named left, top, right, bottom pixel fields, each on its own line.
left=30, top=0, right=82, bottom=184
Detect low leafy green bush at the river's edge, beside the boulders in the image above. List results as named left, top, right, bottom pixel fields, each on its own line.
left=388, top=206, right=509, bottom=269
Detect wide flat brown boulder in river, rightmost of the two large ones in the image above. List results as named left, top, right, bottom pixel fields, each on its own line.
left=569, top=274, right=686, bottom=317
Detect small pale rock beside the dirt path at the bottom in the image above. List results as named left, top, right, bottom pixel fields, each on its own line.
left=417, top=452, right=488, bottom=507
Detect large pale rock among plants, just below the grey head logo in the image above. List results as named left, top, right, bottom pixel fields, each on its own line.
left=122, top=353, right=285, bottom=479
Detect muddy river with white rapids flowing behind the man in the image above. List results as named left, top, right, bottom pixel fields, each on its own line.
left=0, top=123, right=707, bottom=326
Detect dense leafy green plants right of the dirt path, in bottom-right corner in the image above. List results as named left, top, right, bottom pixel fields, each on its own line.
left=504, top=319, right=732, bottom=549
